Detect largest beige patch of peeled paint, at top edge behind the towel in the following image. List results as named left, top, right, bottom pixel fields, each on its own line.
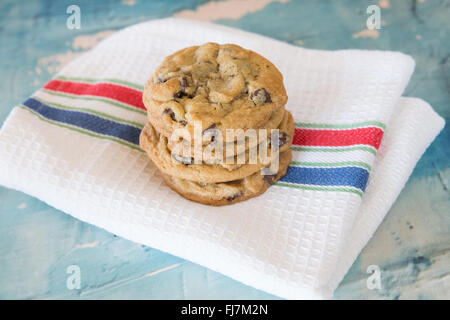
left=173, top=0, right=290, bottom=21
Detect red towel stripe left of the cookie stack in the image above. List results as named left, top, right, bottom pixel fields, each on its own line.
left=44, top=80, right=145, bottom=110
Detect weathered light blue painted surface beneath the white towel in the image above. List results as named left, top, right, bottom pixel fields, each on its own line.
left=0, top=0, right=450, bottom=299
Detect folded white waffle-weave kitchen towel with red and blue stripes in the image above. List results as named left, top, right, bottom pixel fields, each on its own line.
left=0, top=19, right=444, bottom=298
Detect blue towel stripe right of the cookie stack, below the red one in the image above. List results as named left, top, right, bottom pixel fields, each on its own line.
left=280, top=166, right=369, bottom=192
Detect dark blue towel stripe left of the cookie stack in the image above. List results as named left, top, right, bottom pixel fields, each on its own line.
left=23, top=98, right=141, bottom=145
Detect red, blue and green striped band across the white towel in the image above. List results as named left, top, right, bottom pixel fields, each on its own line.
left=20, top=76, right=386, bottom=196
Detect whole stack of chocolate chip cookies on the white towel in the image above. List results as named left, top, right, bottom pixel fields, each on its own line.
left=140, top=43, right=294, bottom=205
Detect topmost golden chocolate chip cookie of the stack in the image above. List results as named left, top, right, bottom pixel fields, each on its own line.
left=143, top=43, right=287, bottom=141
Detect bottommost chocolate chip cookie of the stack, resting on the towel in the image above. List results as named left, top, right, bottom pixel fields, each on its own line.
left=162, top=150, right=292, bottom=206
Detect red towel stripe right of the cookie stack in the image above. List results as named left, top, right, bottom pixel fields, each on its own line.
left=293, top=127, right=383, bottom=149
